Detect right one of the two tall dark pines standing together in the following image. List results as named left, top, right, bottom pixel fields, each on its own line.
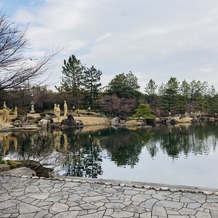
left=83, top=66, right=102, bottom=107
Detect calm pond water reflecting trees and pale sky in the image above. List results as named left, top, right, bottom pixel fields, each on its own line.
left=0, top=123, right=218, bottom=188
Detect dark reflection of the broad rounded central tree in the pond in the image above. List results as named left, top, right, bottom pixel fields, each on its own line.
left=100, top=129, right=152, bottom=167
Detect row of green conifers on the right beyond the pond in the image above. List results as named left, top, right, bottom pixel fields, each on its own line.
left=145, top=77, right=218, bottom=116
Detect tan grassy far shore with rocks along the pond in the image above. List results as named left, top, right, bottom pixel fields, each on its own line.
left=0, top=112, right=217, bottom=132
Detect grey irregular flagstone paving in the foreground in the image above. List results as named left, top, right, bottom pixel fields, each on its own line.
left=0, top=175, right=218, bottom=218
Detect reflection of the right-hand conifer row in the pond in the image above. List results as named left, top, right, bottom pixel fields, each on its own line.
left=154, top=123, right=218, bottom=158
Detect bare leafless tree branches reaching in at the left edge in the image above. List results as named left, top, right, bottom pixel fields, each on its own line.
left=0, top=11, right=58, bottom=91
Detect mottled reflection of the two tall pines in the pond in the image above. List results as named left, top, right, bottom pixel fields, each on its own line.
left=61, top=129, right=102, bottom=178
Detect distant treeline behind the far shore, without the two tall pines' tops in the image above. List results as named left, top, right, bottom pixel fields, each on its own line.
left=0, top=72, right=218, bottom=116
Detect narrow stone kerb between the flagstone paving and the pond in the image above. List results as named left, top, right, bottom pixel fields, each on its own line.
left=0, top=173, right=218, bottom=196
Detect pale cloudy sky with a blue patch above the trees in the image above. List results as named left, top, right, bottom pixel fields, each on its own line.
left=0, top=0, right=218, bottom=91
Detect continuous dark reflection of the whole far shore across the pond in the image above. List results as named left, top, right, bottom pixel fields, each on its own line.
left=0, top=123, right=218, bottom=178
